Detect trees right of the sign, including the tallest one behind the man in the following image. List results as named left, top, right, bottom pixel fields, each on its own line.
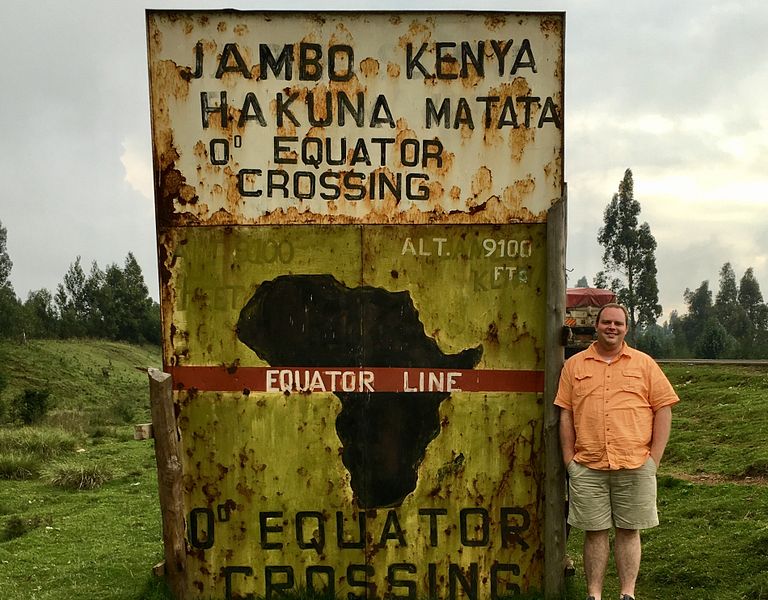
left=577, top=169, right=768, bottom=358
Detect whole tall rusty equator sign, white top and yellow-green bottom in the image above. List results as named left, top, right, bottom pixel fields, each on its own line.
left=147, top=11, right=564, bottom=599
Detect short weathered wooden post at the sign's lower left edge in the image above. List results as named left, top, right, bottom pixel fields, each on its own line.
left=147, top=368, right=188, bottom=600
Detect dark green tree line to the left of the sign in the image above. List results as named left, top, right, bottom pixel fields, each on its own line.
left=0, top=222, right=161, bottom=344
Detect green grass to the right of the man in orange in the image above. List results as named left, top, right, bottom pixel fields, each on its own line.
left=569, top=365, right=768, bottom=600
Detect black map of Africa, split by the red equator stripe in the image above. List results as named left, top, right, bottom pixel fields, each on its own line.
left=237, top=275, right=483, bottom=508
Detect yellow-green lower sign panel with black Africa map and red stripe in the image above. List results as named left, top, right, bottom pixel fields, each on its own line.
left=164, top=224, right=546, bottom=598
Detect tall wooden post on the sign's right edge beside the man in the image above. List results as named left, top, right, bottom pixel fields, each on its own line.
left=544, top=197, right=567, bottom=600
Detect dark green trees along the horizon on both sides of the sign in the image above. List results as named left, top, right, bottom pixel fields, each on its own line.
left=0, top=169, right=768, bottom=358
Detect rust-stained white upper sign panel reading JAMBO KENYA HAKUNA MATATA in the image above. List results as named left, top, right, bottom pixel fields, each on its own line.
left=149, top=12, right=563, bottom=226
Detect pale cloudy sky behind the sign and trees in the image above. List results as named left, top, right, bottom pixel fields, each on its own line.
left=0, top=0, right=768, bottom=321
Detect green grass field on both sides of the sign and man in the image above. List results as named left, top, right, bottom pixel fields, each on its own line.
left=0, top=341, right=768, bottom=600
